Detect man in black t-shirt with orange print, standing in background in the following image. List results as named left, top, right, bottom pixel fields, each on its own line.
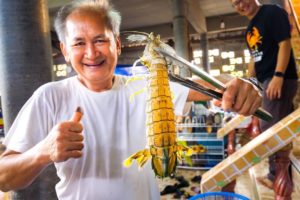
left=231, top=0, right=298, bottom=188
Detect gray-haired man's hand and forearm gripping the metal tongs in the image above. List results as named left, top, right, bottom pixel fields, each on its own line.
left=187, top=78, right=262, bottom=115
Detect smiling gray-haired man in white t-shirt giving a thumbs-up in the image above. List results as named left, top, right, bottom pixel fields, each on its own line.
left=0, top=0, right=261, bottom=200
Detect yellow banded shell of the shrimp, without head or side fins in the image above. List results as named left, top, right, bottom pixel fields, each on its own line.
left=146, top=57, right=177, bottom=177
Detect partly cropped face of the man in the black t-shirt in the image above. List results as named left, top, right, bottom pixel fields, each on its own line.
left=231, top=0, right=258, bottom=19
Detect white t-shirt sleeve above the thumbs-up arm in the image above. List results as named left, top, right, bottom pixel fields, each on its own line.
left=3, top=88, right=52, bottom=152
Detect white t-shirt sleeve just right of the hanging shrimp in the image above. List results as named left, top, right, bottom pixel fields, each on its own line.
left=170, top=82, right=189, bottom=115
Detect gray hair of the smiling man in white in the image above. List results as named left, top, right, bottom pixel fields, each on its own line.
left=54, top=0, right=121, bottom=43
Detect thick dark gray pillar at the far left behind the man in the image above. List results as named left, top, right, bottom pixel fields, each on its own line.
left=0, top=0, right=57, bottom=199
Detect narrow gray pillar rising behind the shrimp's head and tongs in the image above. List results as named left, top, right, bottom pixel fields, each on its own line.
left=172, top=0, right=191, bottom=77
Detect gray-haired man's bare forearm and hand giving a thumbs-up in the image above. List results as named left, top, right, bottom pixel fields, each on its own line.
left=0, top=119, right=83, bottom=192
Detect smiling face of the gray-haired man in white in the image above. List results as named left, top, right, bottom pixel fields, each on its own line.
left=61, top=11, right=121, bottom=91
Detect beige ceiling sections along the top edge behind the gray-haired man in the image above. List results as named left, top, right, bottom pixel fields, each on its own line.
left=48, top=0, right=241, bottom=32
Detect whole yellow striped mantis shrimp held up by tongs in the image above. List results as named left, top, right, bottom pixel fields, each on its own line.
left=124, top=34, right=204, bottom=178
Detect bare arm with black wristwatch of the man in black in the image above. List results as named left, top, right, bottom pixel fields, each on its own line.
left=266, top=39, right=292, bottom=100
